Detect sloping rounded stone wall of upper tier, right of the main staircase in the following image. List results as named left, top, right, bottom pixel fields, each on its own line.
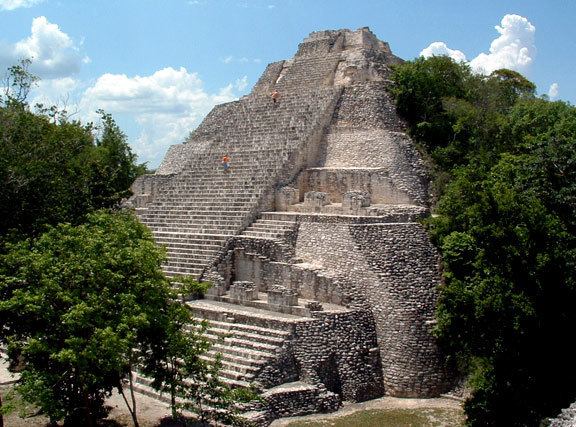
left=321, top=82, right=430, bottom=206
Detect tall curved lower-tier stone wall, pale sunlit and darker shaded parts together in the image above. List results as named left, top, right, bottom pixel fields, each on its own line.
left=296, top=223, right=449, bottom=397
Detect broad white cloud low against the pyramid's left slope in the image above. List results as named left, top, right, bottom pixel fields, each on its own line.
left=80, top=67, right=247, bottom=167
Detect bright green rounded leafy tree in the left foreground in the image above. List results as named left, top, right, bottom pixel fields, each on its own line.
left=0, top=212, right=186, bottom=425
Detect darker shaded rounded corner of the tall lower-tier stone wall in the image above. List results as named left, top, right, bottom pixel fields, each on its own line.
left=350, top=223, right=450, bottom=397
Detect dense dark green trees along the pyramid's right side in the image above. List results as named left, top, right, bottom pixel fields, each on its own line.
left=394, top=58, right=576, bottom=426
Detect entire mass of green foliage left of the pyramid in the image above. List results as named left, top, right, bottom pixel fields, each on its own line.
left=0, top=61, right=252, bottom=426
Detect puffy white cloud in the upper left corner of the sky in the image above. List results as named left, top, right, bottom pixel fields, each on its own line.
left=0, top=16, right=90, bottom=79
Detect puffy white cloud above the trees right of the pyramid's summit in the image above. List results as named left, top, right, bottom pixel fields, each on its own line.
left=420, top=15, right=536, bottom=74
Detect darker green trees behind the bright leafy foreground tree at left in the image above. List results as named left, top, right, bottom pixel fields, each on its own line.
left=0, top=62, right=144, bottom=236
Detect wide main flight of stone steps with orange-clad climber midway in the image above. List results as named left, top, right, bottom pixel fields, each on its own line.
left=136, top=88, right=338, bottom=276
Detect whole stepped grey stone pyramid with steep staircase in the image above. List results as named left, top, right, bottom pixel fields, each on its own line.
left=130, top=28, right=451, bottom=420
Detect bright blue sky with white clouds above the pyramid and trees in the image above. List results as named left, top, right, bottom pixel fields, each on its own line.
left=0, top=0, right=576, bottom=167
